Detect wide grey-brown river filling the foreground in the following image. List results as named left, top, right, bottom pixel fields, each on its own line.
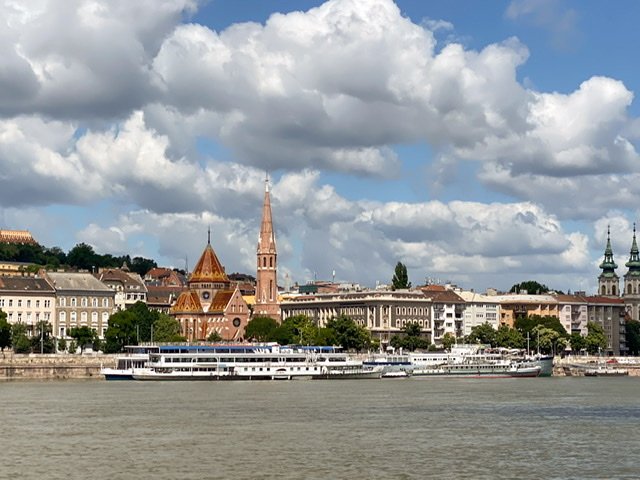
left=0, top=377, right=640, bottom=480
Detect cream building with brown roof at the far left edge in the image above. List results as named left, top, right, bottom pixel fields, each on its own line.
left=0, top=276, right=56, bottom=335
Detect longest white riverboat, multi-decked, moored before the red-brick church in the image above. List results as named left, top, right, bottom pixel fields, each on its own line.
left=105, top=345, right=382, bottom=381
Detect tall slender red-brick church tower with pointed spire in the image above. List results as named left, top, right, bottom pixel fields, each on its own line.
left=253, top=179, right=280, bottom=322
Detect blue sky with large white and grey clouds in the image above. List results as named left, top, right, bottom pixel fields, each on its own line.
left=0, top=0, right=640, bottom=293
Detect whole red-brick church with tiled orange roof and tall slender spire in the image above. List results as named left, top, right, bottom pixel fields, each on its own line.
left=169, top=180, right=280, bottom=341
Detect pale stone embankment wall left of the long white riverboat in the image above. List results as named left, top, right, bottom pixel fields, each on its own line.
left=0, top=352, right=116, bottom=381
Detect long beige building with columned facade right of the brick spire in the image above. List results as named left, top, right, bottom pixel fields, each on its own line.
left=280, top=290, right=432, bottom=345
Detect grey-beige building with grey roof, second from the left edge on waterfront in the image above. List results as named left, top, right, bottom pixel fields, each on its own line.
left=40, top=270, right=117, bottom=338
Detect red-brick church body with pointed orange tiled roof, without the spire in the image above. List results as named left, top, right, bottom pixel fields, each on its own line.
left=169, top=232, right=249, bottom=341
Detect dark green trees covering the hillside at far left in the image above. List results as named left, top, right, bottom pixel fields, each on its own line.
left=0, top=243, right=158, bottom=275
